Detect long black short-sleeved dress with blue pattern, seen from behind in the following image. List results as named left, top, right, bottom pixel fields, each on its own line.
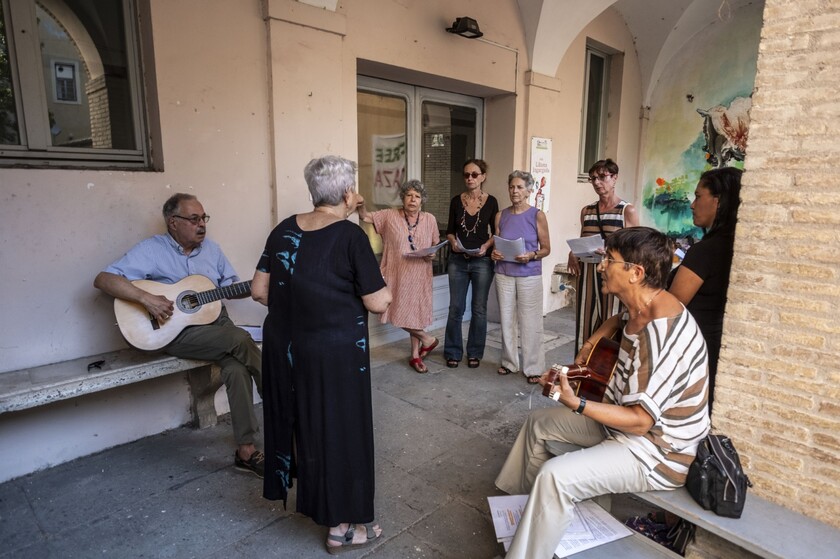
left=257, top=216, right=385, bottom=526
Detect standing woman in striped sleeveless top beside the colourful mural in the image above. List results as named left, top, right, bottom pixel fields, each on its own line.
left=569, top=159, right=639, bottom=353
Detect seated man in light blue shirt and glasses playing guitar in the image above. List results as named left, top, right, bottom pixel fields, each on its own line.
left=93, top=194, right=264, bottom=477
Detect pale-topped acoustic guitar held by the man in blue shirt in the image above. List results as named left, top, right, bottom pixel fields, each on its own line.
left=114, top=275, right=251, bottom=351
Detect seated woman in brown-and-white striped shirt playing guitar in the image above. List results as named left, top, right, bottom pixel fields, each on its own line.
left=496, top=227, right=709, bottom=559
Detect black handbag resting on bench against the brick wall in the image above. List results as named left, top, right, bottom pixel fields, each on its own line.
left=685, top=435, right=752, bottom=518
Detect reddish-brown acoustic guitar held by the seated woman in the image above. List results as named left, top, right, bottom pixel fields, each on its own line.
left=543, top=338, right=620, bottom=402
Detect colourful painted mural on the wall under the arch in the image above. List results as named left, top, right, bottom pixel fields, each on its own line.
left=641, top=7, right=761, bottom=244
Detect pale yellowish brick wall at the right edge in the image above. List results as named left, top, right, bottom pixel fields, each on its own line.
left=708, top=0, right=840, bottom=528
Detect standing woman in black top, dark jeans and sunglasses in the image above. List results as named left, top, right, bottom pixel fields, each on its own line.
left=443, top=159, right=499, bottom=369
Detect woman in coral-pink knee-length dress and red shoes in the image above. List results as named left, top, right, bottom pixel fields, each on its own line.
left=359, top=180, right=440, bottom=373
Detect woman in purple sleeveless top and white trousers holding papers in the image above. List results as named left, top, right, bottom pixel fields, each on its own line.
left=490, top=171, right=551, bottom=384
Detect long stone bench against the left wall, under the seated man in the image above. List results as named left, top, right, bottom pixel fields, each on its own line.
left=0, top=349, right=222, bottom=428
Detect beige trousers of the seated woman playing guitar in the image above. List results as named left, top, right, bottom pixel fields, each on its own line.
left=496, top=407, right=651, bottom=559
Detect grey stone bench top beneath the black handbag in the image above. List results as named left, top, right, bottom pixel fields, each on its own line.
left=633, top=488, right=840, bottom=559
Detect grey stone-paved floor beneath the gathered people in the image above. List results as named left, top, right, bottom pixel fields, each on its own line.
left=0, top=309, right=648, bottom=559
